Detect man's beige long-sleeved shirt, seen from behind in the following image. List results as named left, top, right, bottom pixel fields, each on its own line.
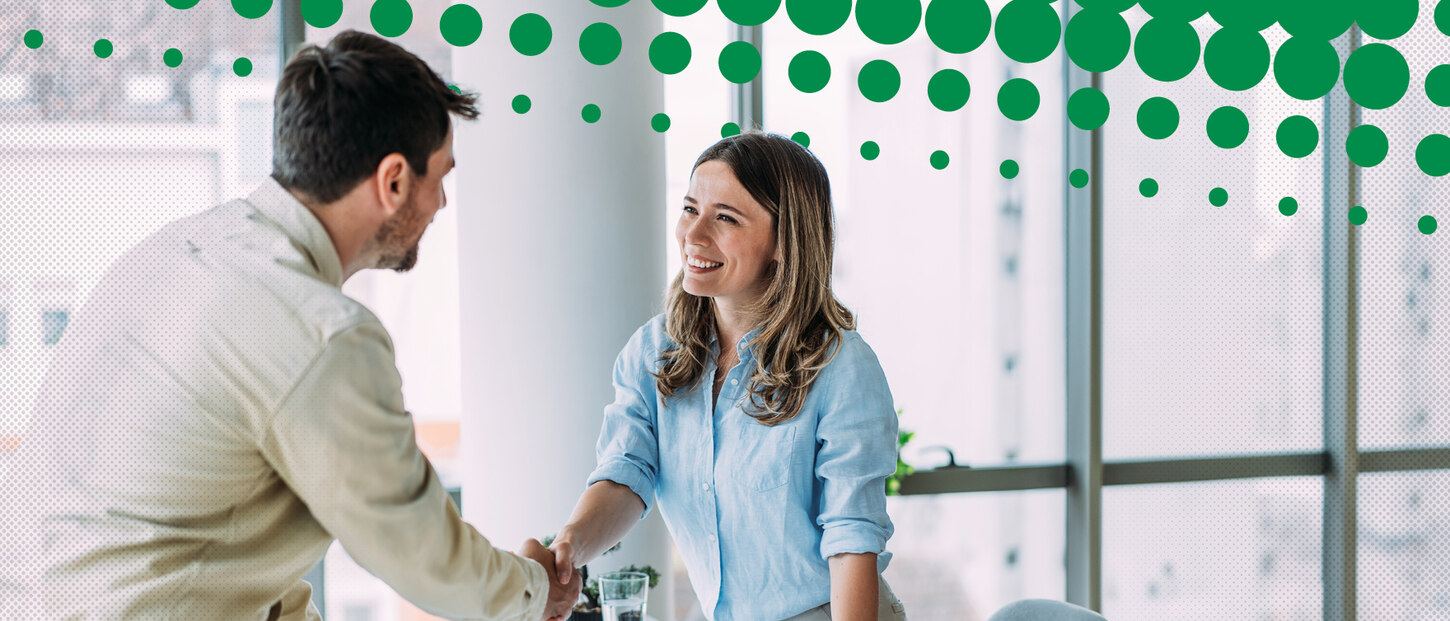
left=0, top=180, right=548, bottom=621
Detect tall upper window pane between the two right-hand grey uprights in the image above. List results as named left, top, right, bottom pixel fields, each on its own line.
left=1102, top=9, right=1328, bottom=460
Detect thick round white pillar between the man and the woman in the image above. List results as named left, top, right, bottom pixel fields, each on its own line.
left=450, top=0, right=673, bottom=621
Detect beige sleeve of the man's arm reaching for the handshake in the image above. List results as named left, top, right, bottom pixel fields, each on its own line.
left=260, top=322, right=548, bottom=621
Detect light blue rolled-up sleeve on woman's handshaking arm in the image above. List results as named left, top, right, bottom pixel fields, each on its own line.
left=586, top=328, right=660, bottom=519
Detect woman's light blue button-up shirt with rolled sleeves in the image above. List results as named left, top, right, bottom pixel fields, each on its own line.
left=589, top=315, right=896, bottom=621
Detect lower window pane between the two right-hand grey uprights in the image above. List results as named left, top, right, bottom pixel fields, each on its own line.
left=1102, top=477, right=1324, bottom=621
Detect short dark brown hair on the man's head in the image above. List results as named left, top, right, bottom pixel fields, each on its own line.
left=273, top=30, right=479, bottom=205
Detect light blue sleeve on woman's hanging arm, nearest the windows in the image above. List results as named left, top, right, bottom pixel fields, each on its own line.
left=812, top=332, right=896, bottom=559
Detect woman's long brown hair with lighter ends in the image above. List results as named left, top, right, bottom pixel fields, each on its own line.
left=655, top=132, right=856, bottom=425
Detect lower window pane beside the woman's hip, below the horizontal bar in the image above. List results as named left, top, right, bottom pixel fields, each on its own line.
left=885, top=489, right=1067, bottom=620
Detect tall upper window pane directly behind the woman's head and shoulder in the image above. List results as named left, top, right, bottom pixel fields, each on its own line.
left=764, top=1, right=1066, bottom=467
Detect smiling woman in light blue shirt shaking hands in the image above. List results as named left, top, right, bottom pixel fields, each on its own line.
left=552, top=132, right=905, bottom=621
